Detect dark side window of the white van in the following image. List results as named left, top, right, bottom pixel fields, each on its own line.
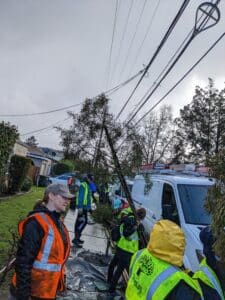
left=162, top=183, right=180, bottom=225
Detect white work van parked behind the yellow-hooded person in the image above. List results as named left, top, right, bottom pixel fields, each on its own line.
left=132, top=174, right=214, bottom=272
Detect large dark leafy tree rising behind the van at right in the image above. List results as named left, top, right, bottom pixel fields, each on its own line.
left=176, top=79, right=225, bottom=162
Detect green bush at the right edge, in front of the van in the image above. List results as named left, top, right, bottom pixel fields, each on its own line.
left=205, top=150, right=225, bottom=262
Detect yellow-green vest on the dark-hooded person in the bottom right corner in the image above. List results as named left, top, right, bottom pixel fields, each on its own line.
left=193, top=258, right=225, bottom=300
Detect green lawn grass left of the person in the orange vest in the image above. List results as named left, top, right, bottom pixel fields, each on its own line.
left=0, top=186, right=44, bottom=269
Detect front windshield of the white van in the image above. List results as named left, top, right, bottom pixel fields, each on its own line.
left=177, top=184, right=211, bottom=225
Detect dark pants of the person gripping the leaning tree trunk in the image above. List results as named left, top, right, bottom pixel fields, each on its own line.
left=108, top=248, right=133, bottom=292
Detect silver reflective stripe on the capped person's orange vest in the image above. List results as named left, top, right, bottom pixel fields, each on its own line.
left=33, top=213, right=62, bottom=272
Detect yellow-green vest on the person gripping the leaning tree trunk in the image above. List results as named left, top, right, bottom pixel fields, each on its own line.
left=116, top=224, right=139, bottom=253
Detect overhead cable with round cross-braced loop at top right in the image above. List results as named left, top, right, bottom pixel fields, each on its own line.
left=125, top=2, right=220, bottom=126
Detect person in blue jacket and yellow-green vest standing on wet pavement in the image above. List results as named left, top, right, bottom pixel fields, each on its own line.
left=72, top=175, right=91, bottom=248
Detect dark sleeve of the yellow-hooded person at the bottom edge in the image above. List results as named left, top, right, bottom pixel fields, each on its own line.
left=165, top=280, right=201, bottom=300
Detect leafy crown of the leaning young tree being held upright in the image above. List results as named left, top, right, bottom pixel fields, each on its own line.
left=57, top=95, right=142, bottom=181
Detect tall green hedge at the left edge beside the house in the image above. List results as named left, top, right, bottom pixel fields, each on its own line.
left=0, top=122, right=19, bottom=193
